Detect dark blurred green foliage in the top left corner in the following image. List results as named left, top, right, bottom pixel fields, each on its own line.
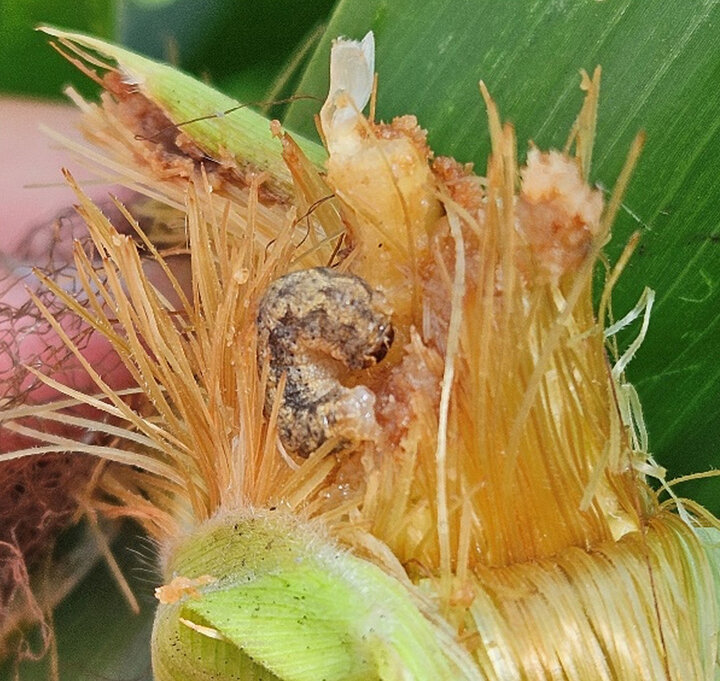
left=0, top=0, right=334, bottom=100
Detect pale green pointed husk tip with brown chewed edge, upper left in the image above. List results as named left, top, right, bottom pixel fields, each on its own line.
left=41, top=26, right=325, bottom=195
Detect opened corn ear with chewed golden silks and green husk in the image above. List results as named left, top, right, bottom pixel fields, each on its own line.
left=5, top=25, right=719, bottom=681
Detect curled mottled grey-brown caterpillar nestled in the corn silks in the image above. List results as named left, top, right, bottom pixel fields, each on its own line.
left=257, top=267, right=393, bottom=457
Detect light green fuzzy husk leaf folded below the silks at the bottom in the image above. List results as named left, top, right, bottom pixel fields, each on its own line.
left=154, top=516, right=464, bottom=681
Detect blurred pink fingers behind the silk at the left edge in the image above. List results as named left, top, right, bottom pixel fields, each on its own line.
left=0, top=98, right=188, bottom=446
